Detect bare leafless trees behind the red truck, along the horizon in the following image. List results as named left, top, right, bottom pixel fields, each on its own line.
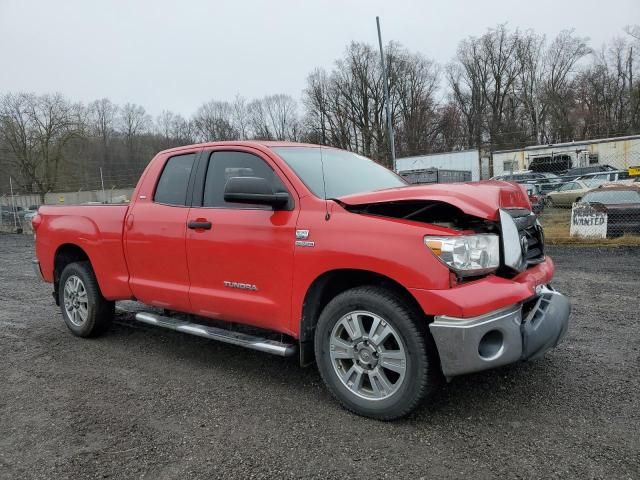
left=0, top=25, right=640, bottom=195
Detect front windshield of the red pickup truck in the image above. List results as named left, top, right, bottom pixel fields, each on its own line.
left=272, top=147, right=407, bottom=198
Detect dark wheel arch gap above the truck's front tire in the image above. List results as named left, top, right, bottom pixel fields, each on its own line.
left=299, top=269, right=427, bottom=366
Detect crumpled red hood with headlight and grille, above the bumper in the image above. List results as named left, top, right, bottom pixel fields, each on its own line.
left=338, top=183, right=545, bottom=282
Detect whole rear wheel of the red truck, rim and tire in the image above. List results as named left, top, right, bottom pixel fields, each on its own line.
left=58, top=262, right=115, bottom=337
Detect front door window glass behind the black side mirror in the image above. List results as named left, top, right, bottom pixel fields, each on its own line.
left=202, top=152, right=287, bottom=208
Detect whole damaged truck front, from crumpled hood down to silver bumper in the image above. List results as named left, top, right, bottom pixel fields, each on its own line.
left=341, top=182, right=571, bottom=379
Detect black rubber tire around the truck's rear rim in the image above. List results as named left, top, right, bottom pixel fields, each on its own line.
left=58, top=261, right=115, bottom=337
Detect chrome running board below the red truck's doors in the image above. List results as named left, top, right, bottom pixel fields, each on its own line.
left=135, top=312, right=297, bottom=357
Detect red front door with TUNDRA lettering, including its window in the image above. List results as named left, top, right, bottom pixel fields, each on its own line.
left=187, top=147, right=298, bottom=331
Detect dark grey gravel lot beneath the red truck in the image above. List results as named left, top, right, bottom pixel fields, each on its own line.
left=0, top=235, right=640, bottom=480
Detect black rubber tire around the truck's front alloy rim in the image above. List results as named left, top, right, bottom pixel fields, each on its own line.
left=315, top=286, right=441, bottom=420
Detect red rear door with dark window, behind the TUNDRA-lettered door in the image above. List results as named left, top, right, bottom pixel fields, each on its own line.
left=124, top=151, right=199, bottom=312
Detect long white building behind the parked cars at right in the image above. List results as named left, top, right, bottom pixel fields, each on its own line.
left=493, top=135, right=640, bottom=175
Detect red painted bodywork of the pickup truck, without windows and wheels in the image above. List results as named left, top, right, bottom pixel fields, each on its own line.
left=36, top=142, right=553, bottom=337
